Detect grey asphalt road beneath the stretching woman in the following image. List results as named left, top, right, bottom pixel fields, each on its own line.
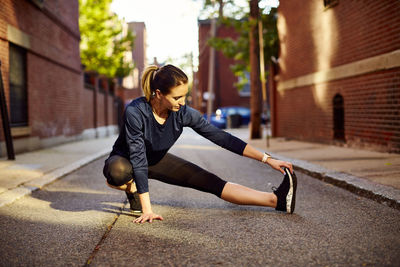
left=0, top=131, right=400, bottom=266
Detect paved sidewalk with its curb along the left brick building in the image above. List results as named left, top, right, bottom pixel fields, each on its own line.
left=0, top=135, right=117, bottom=207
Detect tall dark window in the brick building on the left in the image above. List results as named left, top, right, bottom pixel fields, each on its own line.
left=10, top=43, right=28, bottom=127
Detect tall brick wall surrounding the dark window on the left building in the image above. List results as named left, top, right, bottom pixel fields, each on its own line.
left=0, top=0, right=83, bottom=144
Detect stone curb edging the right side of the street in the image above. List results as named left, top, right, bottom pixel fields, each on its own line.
left=270, top=153, right=400, bottom=210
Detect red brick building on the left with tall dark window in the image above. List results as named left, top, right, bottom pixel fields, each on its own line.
left=0, top=0, right=117, bottom=156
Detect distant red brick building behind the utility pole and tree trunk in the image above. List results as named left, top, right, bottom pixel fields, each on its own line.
left=192, top=20, right=250, bottom=113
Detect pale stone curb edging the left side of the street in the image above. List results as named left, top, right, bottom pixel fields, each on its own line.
left=0, top=149, right=110, bottom=207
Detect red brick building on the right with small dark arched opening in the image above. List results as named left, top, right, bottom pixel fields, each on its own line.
left=272, top=0, right=400, bottom=153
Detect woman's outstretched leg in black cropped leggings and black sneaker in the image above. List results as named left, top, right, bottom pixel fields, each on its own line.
left=149, top=153, right=297, bottom=213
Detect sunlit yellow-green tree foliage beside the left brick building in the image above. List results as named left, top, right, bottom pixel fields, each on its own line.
left=79, top=0, right=134, bottom=78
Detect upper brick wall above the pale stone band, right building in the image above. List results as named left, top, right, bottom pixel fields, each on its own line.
left=278, top=0, right=400, bottom=80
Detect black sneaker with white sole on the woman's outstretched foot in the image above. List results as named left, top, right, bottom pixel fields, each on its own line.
left=273, top=168, right=297, bottom=213
